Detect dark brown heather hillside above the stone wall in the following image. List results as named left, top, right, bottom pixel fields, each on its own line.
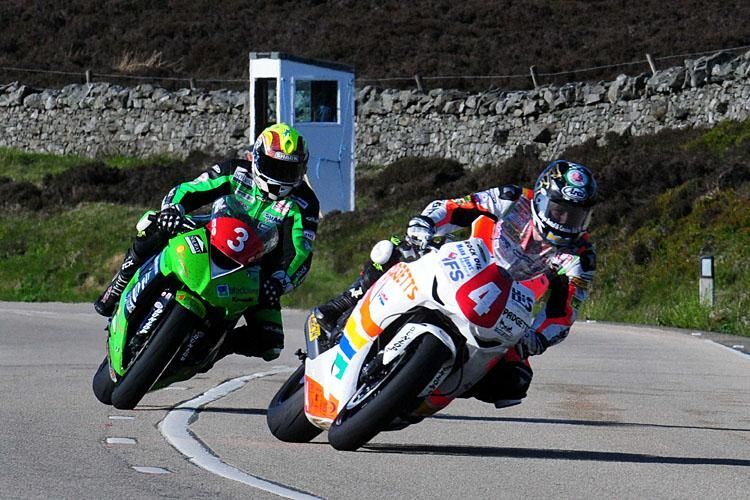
left=0, top=0, right=750, bottom=90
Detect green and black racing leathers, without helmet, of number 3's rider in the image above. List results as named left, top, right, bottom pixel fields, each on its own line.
left=97, top=159, right=319, bottom=360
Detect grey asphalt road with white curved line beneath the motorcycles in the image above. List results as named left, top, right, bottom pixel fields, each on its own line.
left=0, top=303, right=750, bottom=499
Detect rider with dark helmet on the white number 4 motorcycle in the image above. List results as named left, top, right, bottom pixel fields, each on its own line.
left=315, top=160, right=596, bottom=407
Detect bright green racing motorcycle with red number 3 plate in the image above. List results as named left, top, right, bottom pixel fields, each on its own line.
left=93, top=195, right=278, bottom=409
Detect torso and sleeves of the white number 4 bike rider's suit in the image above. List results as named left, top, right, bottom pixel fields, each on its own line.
left=421, top=186, right=596, bottom=354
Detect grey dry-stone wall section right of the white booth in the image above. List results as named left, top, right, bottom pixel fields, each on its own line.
left=357, top=52, right=750, bottom=165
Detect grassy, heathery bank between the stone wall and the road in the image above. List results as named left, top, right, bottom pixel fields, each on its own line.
left=0, top=122, right=750, bottom=335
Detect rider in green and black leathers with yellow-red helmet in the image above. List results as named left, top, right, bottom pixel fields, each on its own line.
left=94, top=123, right=320, bottom=361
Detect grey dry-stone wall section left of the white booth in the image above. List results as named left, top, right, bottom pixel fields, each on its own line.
left=0, top=83, right=250, bottom=157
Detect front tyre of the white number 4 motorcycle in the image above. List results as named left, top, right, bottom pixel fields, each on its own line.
left=328, top=334, right=451, bottom=451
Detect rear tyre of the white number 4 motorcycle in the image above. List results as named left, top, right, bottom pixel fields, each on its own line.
left=266, top=364, right=323, bottom=443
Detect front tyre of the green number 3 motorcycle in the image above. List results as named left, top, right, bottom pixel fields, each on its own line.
left=112, top=303, right=196, bottom=410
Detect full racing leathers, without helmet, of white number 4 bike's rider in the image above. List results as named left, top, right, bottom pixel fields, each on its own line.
left=316, top=185, right=596, bottom=407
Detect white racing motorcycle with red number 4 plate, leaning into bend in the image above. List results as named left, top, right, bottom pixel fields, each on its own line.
left=267, top=216, right=536, bottom=450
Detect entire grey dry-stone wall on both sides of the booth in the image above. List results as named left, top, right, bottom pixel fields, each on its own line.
left=0, top=52, right=750, bottom=165
